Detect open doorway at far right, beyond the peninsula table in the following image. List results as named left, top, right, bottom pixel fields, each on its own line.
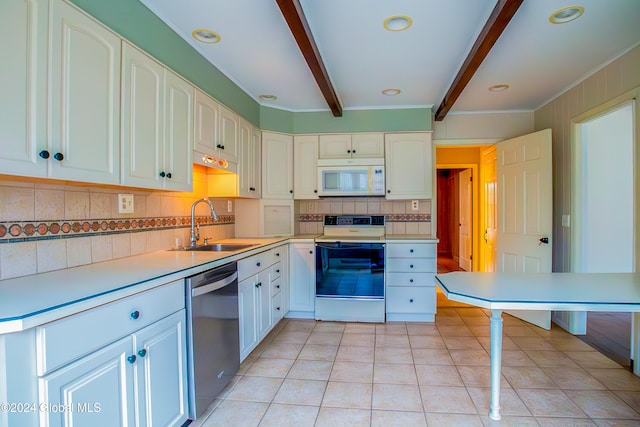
left=565, top=97, right=636, bottom=369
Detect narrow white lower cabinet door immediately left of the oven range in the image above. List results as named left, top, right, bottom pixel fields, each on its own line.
left=289, top=243, right=316, bottom=316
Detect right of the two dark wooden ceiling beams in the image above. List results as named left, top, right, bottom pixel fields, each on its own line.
left=435, top=0, right=524, bottom=121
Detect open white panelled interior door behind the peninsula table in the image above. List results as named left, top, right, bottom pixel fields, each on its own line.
left=496, top=129, right=553, bottom=329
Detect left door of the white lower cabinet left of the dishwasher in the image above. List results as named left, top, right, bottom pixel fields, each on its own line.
left=39, top=336, right=135, bottom=427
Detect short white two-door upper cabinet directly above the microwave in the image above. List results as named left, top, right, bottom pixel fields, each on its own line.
left=318, top=133, right=384, bottom=159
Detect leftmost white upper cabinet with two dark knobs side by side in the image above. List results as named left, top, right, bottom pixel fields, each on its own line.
left=0, top=0, right=120, bottom=184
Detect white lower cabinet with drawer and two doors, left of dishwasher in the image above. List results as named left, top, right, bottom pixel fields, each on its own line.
left=36, top=280, right=187, bottom=426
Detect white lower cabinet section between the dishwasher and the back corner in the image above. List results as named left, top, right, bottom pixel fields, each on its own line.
left=238, top=244, right=287, bottom=361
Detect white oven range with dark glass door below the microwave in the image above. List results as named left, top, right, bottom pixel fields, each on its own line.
left=315, top=215, right=385, bottom=322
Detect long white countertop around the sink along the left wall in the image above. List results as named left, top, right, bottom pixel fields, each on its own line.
left=0, top=237, right=290, bottom=333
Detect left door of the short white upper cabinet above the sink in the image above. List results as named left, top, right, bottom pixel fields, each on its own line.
left=194, top=89, right=220, bottom=156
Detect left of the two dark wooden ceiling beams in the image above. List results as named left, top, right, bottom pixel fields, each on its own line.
left=276, top=0, right=342, bottom=117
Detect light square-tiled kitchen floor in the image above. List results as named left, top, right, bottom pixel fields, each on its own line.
left=192, top=300, right=640, bottom=427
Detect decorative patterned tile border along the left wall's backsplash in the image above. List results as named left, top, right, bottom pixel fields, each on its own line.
left=0, top=215, right=235, bottom=243
